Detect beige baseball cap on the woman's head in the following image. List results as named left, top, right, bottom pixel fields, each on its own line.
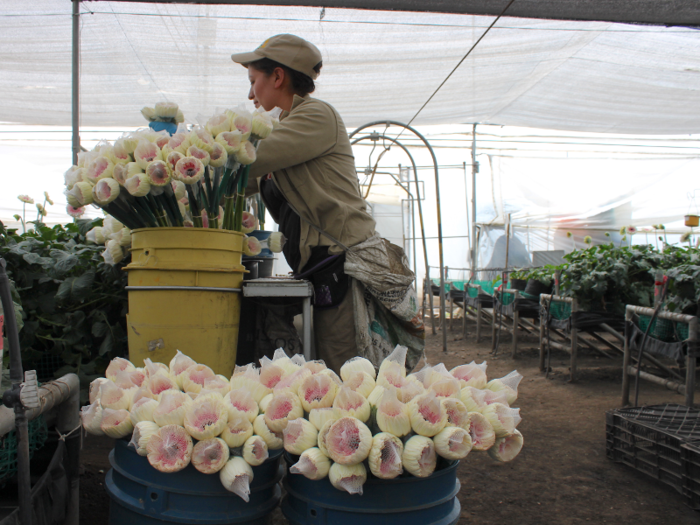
left=231, top=34, right=323, bottom=79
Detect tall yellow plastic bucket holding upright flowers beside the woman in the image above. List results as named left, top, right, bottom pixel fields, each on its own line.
left=125, top=228, right=245, bottom=377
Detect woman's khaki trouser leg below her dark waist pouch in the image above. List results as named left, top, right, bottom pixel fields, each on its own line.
left=314, top=279, right=357, bottom=374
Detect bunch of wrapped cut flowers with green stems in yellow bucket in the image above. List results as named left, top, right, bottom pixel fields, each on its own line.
left=64, top=103, right=278, bottom=250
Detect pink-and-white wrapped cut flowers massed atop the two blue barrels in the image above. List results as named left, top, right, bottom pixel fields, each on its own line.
left=82, top=346, right=523, bottom=501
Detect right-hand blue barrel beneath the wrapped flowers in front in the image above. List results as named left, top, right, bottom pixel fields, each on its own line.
left=282, top=457, right=462, bottom=525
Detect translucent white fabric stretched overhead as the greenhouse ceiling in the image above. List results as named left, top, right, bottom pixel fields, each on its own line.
left=0, top=0, right=700, bottom=135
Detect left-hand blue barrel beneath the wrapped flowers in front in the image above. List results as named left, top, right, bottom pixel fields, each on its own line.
left=105, top=439, right=284, bottom=525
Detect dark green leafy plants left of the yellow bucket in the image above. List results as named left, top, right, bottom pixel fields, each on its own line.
left=0, top=219, right=128, bottom=398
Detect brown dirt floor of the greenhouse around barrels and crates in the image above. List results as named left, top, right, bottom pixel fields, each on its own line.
left=80, top=323, right=700, bottom=525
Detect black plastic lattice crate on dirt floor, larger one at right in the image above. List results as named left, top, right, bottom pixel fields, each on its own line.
left=605, top=404, right=700, bottom=493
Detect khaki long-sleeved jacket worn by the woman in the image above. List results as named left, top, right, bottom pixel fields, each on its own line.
left=246, top=95, right=375, bottom=271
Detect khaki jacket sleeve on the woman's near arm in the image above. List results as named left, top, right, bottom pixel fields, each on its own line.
left=250, top=101, right=338, bottom=179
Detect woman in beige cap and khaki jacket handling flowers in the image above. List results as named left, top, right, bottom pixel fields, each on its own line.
left=231, top=34, right=375, bottom=372
